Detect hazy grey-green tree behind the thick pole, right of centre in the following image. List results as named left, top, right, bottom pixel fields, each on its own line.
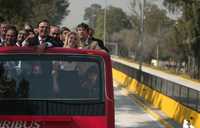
left=130, top=0, right=174, bottom=62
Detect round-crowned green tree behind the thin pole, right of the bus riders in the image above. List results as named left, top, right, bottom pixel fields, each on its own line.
left=84, top=4, right=132, bottom=56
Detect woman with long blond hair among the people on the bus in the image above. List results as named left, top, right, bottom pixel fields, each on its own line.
left=63, top=32, right=80, bottom=48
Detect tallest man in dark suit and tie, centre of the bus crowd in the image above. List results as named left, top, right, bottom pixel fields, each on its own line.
left=22, top=20, right=61, bottom=48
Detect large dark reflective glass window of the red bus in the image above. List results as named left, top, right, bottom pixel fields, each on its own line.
left=0, top=55, right=103, bottom=100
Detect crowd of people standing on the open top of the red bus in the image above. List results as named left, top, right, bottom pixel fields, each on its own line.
left=0, top=20, right=108, bottom=52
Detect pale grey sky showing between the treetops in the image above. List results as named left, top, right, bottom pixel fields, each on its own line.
left=62, top=0, right=131, bottom=29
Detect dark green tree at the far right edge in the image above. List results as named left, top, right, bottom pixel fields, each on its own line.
left=164, top=0, right=200, bottom=78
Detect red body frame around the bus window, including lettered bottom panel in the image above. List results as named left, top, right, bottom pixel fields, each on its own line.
left=0, top=47, right=115, bottom=128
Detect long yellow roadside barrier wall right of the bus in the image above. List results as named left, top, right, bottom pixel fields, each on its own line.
left=112, top=62, right=200, bottom=128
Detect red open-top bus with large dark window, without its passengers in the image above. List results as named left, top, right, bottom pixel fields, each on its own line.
left=0, top=47, right=114, bottom=128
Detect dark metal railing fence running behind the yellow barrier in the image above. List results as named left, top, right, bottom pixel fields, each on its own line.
left=113, top=61, right=200, bottom=112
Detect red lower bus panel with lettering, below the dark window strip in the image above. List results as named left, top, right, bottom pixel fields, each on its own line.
left=0, top=115, right=109, bottom=128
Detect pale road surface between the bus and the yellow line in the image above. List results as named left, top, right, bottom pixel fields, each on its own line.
left=114, top=83, right=164, bottom=128
